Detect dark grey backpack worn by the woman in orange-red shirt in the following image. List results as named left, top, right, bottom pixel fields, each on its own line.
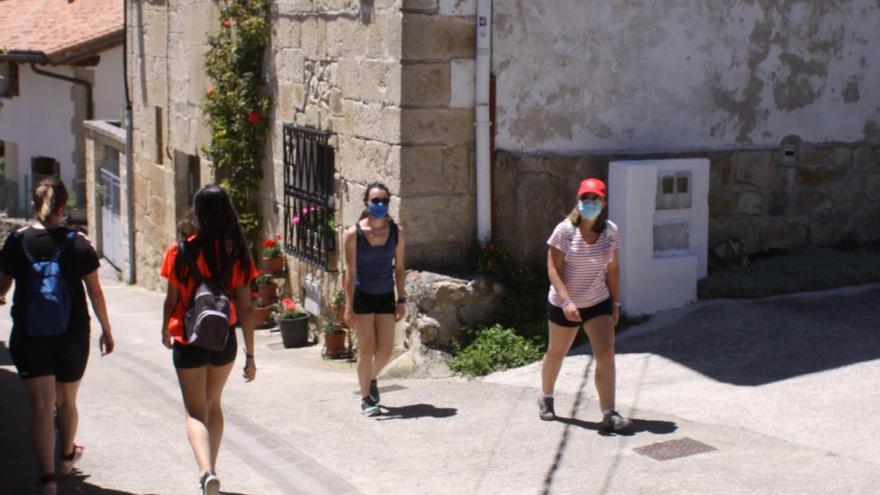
left=177, top=241, right=232, bottom=351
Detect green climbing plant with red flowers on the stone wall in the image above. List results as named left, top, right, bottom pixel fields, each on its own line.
left=203, top=0, right=271, bottom=243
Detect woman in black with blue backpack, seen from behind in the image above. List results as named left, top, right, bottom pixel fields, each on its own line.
left=0, top=178, right=114, bottom=495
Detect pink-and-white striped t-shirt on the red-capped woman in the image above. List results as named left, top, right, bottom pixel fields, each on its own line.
left=547, top=219, right=622, bottom=308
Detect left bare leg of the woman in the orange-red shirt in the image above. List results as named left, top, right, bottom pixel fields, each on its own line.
left=177, top=366, right=211, bottom=474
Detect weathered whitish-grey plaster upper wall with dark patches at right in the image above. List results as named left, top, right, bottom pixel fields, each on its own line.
left=493, top=0, right=880, bottom=153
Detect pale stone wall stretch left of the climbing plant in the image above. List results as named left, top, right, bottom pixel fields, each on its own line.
left=128, top=0, right=219, bottom=289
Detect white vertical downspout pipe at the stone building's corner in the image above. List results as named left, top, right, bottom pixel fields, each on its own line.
left=475, top=0, right=492, bottom=246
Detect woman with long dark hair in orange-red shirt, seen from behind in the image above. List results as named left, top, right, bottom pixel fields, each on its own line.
left=162, top=185, right=259, bottom=495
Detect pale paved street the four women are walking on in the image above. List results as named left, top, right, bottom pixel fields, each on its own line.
left=0, top=281, right=880, bottom=495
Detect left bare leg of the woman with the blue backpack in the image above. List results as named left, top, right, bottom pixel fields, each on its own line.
left=24, top=375, right=55, bottom=475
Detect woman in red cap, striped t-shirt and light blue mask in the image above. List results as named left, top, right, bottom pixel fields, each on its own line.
left=538, top=178, right=632, bottom=431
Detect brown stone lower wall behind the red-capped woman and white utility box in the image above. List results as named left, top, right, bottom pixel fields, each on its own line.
left=495, top=143, right=880, bottom=263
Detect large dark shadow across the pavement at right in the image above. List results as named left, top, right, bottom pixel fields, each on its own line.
left=579, top=289, right=880, bottom=386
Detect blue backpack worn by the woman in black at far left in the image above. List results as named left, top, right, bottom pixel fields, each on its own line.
left=21, top=231, right=76, bottom=336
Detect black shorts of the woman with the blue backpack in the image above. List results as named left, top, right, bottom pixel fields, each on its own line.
left=9, top=329, right=89, bottom=383
